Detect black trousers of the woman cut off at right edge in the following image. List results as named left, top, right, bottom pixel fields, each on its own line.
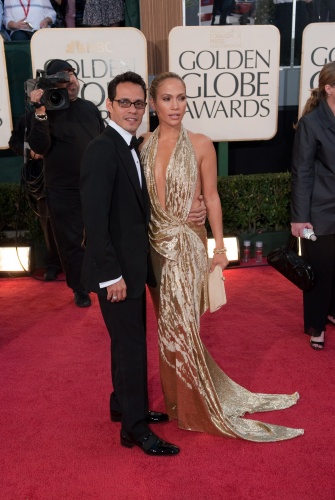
left=301, top=234, right=335, bottom=337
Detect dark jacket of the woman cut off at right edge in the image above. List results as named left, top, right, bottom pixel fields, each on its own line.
left=291, top=101, right=335, bottom=236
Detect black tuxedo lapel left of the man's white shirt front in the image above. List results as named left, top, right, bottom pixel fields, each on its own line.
left=105, top=126, right=146, bottom=212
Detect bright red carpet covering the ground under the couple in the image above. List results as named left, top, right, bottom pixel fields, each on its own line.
left=0, top=266, right=335, bottom=500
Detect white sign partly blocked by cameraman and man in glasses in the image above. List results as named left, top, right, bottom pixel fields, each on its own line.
left=31, top=28, right=149, bottom=133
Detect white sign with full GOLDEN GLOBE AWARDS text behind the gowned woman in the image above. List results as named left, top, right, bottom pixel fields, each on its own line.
left=169, top=26, right=280, bottom=142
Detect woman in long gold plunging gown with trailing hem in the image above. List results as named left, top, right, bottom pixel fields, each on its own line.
left=141, top=73, right=303, bottom=442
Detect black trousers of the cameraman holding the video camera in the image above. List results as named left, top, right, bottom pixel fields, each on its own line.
left=46, top=187, right=84, bottom=290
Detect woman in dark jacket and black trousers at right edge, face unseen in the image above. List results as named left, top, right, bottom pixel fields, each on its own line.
left=291, top=62, right=335, bottom=350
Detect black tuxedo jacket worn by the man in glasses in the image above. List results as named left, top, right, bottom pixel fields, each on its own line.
left=80, top=126, right=153, bottom=298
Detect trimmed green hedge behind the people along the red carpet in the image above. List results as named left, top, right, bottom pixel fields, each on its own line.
left=0, top=172, right=291, bottom=241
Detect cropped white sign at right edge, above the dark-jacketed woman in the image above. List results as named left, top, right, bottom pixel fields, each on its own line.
left=299, top=23, right=335, bottom=116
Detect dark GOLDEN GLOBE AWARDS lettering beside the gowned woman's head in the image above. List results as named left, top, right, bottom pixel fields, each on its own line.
left=179, top=50, right=271, bottom=118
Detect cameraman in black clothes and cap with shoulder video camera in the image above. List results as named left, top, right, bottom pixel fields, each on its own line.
left=27, top=59, right=104, bottom=307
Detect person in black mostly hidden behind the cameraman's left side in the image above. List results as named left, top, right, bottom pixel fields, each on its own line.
left=8, top=111, right=62, bottom=281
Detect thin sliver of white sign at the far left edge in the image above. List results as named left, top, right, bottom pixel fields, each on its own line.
left=0, top=36, right=12, bottom=149
